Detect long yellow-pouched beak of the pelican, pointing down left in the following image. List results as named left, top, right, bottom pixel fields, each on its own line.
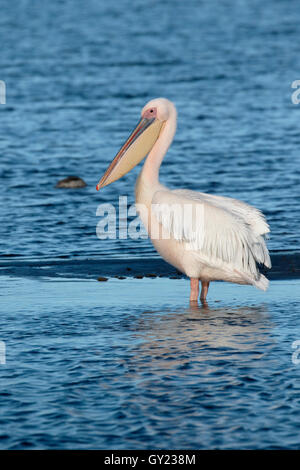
left=96, top=117, right=163, bottom=191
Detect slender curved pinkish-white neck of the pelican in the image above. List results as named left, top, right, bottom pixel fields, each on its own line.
left=140, top=106, right=177, bottom=185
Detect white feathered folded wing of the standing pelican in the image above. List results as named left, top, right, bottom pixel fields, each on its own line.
left=152, top=190, right=271, bottom=277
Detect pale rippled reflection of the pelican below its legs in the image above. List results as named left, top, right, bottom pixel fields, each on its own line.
left=120, top=304, right=273, bottom=374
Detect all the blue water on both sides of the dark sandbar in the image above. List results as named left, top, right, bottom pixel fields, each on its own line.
left=0, top=0, right=300, bottom=448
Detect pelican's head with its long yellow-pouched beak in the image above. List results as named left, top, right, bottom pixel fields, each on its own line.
left=96, top=98, right=175, bottom=190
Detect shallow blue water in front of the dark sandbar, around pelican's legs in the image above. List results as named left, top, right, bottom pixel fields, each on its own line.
left=0, top=277, right=300, bottom=449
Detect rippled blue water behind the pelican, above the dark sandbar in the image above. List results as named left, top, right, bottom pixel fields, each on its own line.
left=0, top=0, right=300, bottom=257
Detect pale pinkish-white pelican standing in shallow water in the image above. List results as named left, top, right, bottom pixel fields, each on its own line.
left=96, top=98, right=271, bottom=302
